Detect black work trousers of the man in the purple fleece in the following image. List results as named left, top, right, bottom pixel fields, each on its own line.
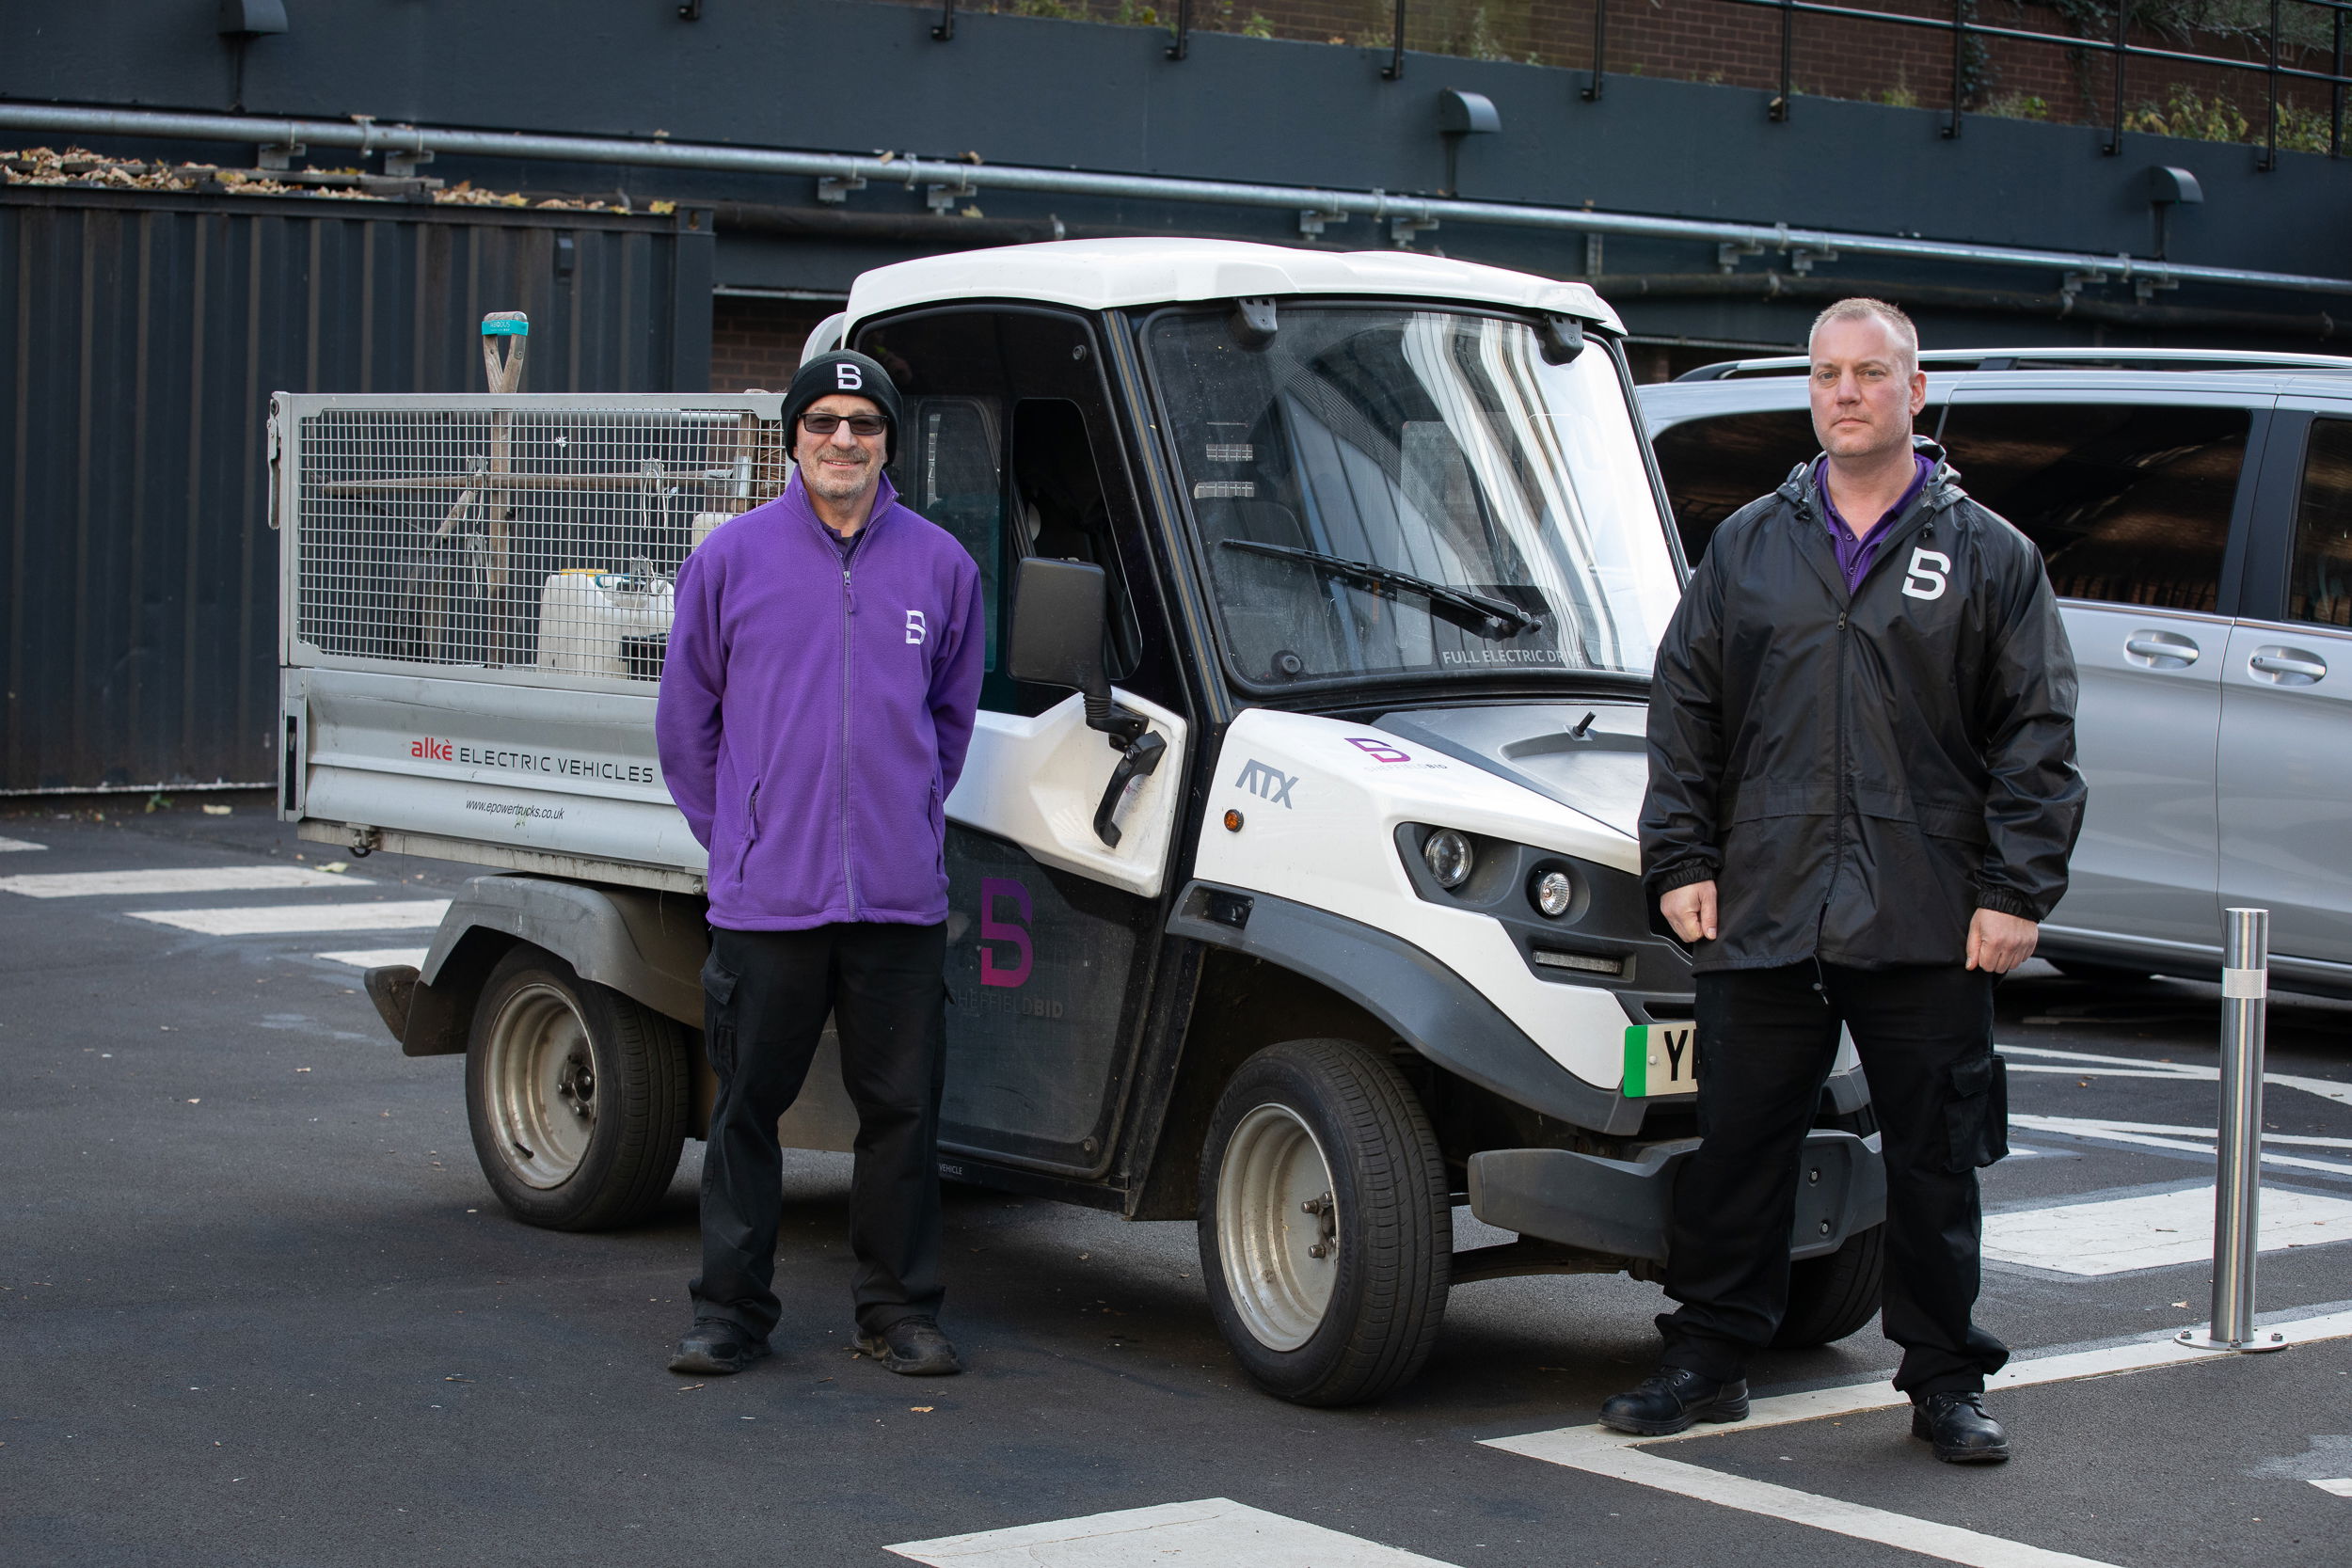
left=690, top=924, right=948, bottom=1340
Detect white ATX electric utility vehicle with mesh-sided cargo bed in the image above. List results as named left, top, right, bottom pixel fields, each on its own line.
left=273, top=240, right=1884, bottom=1403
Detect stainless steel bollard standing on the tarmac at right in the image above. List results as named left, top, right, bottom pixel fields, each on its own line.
left=2181, top=910, right=2286, bottom=1350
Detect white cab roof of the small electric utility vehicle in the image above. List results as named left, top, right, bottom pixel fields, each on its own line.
left=847, top=237, right=1626, bottom=331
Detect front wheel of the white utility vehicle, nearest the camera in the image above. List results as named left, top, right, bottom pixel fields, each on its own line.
left=1200, top=1039, right=1454, bottom=1406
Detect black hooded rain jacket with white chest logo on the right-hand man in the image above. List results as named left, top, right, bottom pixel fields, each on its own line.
left=1642, top=439, right=2084, bottom=974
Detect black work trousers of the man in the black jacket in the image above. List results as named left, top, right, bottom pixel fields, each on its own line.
left=1659, top=964, right=2009, bottom=1399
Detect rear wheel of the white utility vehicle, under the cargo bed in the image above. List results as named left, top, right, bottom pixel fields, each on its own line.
left=466, top=942, right=691, bottom=1229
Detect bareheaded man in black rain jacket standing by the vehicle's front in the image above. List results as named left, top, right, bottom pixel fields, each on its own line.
left=1602, top=298, right=2084, bottom=1463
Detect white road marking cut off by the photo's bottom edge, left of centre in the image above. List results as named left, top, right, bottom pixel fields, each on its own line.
left=887, top=1497, right=1452, bottom=1568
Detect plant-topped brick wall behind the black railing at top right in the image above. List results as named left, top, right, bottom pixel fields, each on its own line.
left=875, top=0, right=2328, bottom=139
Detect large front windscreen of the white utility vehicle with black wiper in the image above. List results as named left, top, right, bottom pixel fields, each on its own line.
left=1146, top=298, right=1679, bottom=689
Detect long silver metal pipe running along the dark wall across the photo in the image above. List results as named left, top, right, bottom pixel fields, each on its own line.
left=13, top=103, right=2352, bottom=293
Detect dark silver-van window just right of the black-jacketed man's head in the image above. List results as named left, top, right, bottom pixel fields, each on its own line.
left=1943, top=402, right=2253, bottom=613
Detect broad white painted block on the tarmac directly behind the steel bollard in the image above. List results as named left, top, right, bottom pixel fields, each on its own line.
left=1985, top=1185, right=2352, bottom=1276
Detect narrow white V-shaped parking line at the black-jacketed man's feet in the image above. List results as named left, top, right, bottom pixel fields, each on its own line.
left=1485, top=1312, right=2352, bottom=1568
